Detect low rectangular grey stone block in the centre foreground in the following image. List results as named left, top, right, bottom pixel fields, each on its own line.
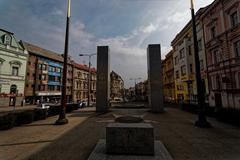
left=106, top=123, right=154, bottom=155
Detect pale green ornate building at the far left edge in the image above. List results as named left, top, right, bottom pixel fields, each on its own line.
left=0, top=29, right=28, bottom=106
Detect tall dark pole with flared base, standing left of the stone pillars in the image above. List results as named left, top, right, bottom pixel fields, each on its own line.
left=55, top=0, right=71, bottom=125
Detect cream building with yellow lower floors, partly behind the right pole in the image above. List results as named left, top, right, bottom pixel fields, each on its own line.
left=172, top=8, right=209, bottom=103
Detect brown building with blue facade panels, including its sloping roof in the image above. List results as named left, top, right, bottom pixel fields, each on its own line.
left=21, top=42, right=73, bottom=104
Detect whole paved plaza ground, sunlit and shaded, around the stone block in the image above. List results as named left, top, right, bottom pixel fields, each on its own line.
left=0, top=104, right=240, bottom=160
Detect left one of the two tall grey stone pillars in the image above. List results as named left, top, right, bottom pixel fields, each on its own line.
left=96, top=46, right=110, bottom=112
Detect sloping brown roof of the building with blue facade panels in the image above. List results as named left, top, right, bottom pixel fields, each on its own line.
left=21, top=41, right=63, bottom=62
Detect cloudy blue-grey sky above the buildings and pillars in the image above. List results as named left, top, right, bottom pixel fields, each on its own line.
left=0, top=0, right=213, bottom=87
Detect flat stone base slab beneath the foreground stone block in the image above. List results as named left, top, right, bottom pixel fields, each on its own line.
left=88, top=139, right=173, bottom=160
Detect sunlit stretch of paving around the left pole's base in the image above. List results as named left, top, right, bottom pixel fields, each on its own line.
left=0, top=108, right=95, bottom=160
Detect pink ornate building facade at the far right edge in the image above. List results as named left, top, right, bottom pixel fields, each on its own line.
left=201, top=0, right=240, bottom=109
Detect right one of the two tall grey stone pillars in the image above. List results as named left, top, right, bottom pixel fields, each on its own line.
left=147, top=44, right=164, bottom=113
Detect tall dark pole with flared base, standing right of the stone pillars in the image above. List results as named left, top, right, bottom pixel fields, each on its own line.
left=190, top=0, right=211, bottom=128
